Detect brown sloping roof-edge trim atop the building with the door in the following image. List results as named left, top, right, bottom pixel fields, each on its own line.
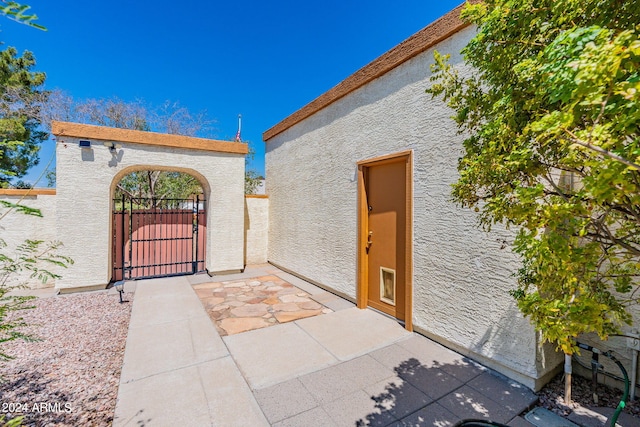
left=262, top=0, right=480, bottom=142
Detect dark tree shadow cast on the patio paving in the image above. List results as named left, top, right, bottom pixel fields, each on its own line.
left=355, top=358, right=537, bottom=427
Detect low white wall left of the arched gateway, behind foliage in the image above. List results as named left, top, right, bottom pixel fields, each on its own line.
left=0, top=194, right=58, bottom=288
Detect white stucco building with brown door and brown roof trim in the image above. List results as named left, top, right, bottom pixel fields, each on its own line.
left=263, top=4, right=561, bottom=389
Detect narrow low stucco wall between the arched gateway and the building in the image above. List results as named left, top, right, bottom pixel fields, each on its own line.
left=244, top=196, right=269, bottom=264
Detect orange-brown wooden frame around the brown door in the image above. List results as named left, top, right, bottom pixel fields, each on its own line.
left=357, top=150, right=413, bottom=331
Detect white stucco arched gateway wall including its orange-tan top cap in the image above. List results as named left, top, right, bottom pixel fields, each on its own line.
left=52, top=122, right=248, bottom=291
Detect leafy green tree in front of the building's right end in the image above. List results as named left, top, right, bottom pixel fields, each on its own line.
left=427, top=0, right=640, bottom=362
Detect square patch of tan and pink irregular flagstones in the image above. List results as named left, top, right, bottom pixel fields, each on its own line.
left=193, top=275, right=333, bottom=336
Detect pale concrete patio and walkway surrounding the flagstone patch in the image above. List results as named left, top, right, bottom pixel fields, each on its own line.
left=113, top=265, right=537, bottom=426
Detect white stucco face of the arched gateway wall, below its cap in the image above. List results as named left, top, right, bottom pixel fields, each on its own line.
left=56, top=136, right=244, bottom=290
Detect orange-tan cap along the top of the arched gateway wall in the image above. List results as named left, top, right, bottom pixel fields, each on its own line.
left=51, top=121, right=249, bottom=155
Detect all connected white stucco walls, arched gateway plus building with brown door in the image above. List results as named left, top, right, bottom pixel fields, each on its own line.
left=0, top=3, right=562, bottom=389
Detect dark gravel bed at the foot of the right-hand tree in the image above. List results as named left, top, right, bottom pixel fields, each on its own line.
left=538, top=374, right=640, bottom=425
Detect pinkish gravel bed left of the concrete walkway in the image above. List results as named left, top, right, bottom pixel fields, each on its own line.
left=0, top=292, right=133, bottom=427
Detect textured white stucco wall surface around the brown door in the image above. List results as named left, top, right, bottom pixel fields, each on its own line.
left=266, top=28, right=559, bottom=388
